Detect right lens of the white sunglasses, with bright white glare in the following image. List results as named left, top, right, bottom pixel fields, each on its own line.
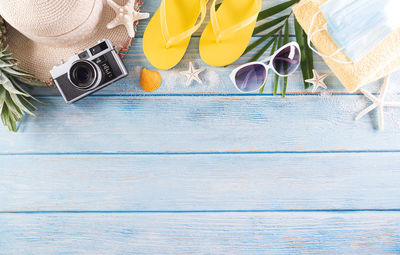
left=272, top=45, right=300, bottom=75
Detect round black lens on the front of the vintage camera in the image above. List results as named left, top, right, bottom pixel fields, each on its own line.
left=69, top=61, right=97, bottom=89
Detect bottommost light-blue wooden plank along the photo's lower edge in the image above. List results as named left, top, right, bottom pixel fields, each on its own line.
left=0, top=212, right=400, bottom=255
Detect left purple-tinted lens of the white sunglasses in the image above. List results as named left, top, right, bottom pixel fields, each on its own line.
left=235, top=64, right=267, bottom=92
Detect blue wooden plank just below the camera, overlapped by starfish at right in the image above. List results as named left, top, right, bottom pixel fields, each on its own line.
left=0, top=96, right=400, bottom=154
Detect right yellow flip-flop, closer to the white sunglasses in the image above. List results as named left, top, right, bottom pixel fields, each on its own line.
left=199, top=0, right=262, bottom=66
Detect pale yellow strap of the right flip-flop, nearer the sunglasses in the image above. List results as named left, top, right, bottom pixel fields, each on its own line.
left=210, top=0, right=262, bottom=43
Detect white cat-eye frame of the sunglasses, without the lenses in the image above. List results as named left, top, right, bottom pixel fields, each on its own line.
left=229, top=42, right=301, bottom=93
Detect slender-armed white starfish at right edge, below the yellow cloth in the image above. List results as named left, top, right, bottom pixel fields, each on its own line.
left=356, top=75, right=400, bottom=130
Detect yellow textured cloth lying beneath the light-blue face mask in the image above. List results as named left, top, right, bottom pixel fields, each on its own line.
left=293, top=0, right=400, bottom=92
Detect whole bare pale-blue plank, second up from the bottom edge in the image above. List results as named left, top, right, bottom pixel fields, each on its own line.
left=0, top=153, right=400, bottom=211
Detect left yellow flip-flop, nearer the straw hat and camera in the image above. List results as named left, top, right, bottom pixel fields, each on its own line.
left=143, top=0, right=208, bottom=70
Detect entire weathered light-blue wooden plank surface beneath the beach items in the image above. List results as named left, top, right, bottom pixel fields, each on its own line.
left=0, top=0, right=400, bottom=254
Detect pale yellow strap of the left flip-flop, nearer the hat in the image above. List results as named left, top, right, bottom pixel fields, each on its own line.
left=160, top=0, right=208, bottom=48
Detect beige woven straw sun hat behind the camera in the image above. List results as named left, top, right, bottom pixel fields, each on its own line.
left=0, top=0, right=138, bottom=81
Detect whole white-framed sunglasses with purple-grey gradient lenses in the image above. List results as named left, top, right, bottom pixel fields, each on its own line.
left=230, top=42, right=301, bottom=93
